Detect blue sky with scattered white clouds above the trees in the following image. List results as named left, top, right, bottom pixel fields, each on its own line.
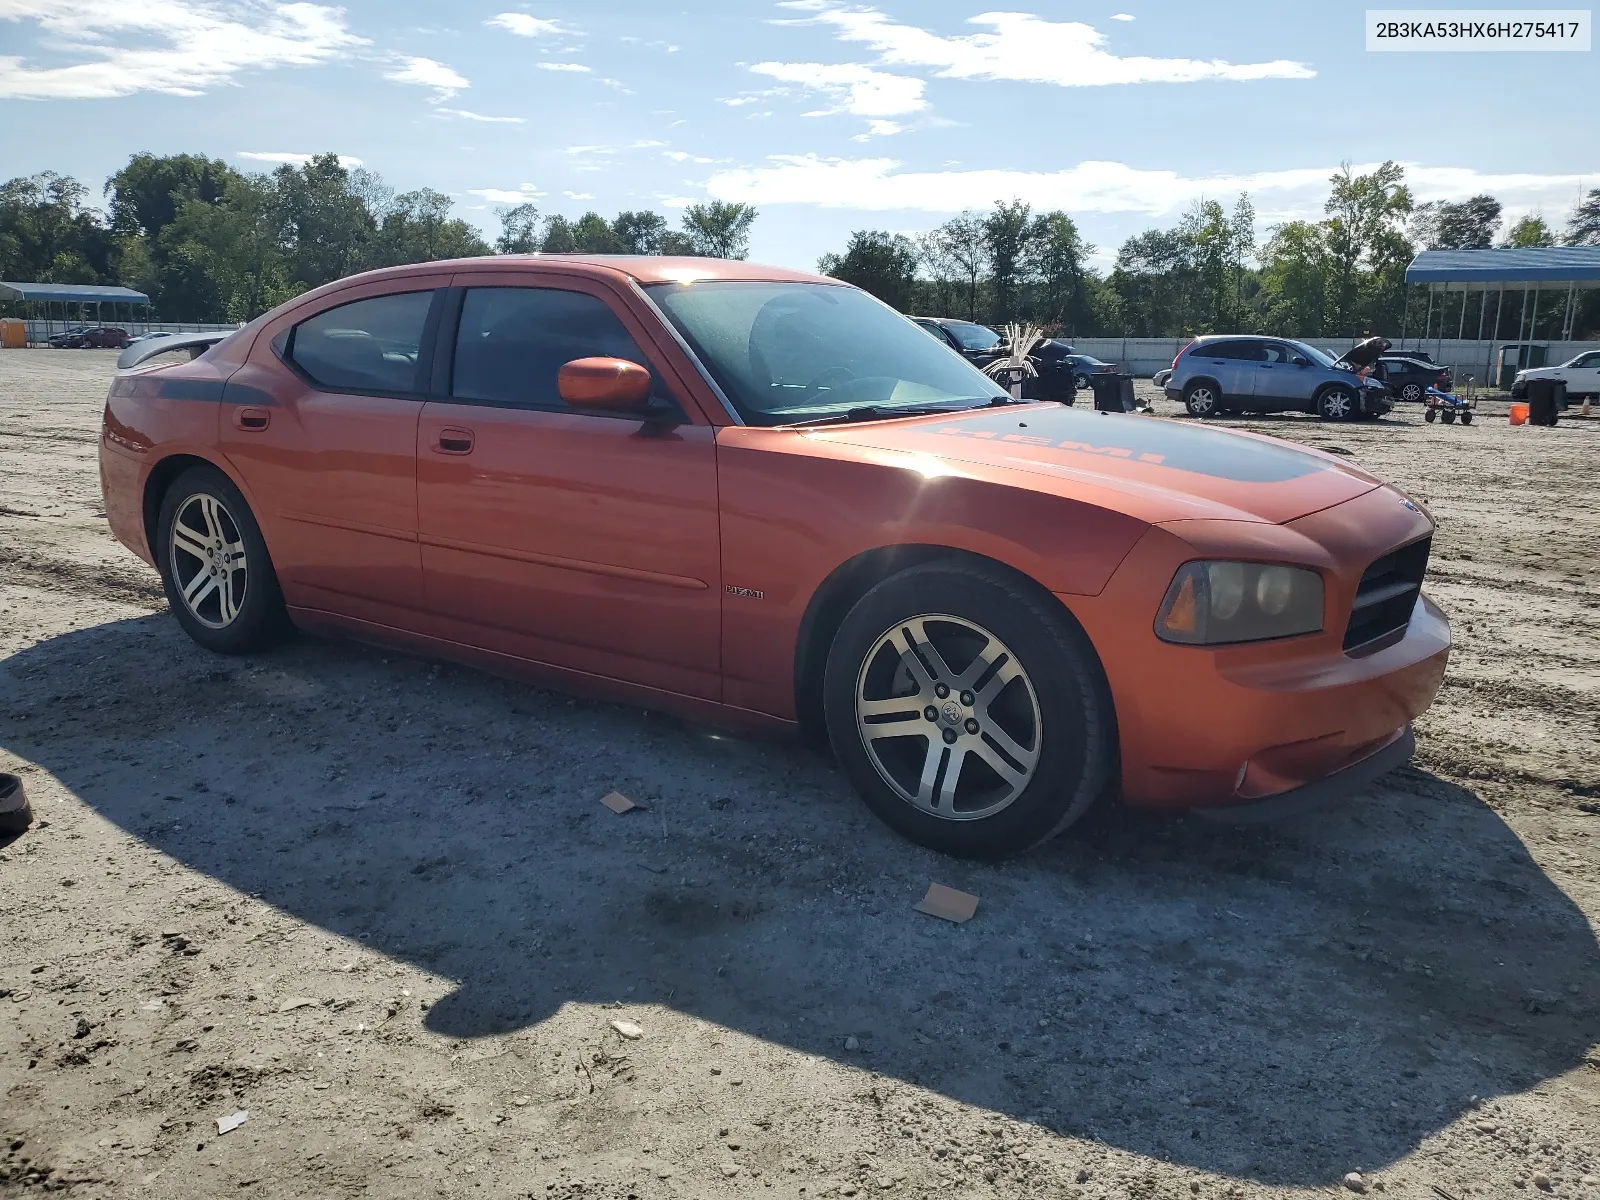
left=0, top=0, right=1600, bottom=269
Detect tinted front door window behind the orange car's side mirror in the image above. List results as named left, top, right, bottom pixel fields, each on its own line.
left=450, top=288, right=680, bottom=419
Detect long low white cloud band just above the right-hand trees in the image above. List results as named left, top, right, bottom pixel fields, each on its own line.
left=706, top=155, right=1600, bottom=221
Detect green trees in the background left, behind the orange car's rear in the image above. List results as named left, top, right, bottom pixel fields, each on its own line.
left=0, top=154, right=757, bottom=322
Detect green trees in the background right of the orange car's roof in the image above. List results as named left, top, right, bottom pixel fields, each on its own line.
left=818, top=162, right=1600, bottom=338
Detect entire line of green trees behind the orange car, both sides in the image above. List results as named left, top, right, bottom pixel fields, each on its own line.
left=0, top=154, right=1600, bottom=338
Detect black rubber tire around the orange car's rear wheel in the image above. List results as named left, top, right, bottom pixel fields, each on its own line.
left=155, top=467, right=288, bottom=654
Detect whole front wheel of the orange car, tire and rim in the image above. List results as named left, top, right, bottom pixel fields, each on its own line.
left=822, top=562, right=1115, bottom=859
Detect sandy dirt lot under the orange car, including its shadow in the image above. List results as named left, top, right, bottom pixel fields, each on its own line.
left=0, top=350, right=1600, bottom=1200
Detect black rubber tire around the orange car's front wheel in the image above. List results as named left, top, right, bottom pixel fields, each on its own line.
left=822, top=560, right=1115, bottom=859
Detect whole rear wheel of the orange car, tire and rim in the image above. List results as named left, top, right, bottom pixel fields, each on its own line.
left=157, top=467, right=286, bottom=654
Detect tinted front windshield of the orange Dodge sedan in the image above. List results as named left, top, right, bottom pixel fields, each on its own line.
left=646, top=280, right=1000, bottom=426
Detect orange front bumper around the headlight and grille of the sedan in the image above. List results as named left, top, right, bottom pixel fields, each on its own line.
left=1061, top=488, right=1450, bottom=811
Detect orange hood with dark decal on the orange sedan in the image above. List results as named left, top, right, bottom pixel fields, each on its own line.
left=806, top=405, right=1381, bottom=525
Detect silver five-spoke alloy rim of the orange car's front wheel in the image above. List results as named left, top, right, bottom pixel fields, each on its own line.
left=856, top=616, right=1043, bottom=821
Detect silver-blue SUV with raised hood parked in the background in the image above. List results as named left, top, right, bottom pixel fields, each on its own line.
left=1166, top=334, right=1394, bottom=421
